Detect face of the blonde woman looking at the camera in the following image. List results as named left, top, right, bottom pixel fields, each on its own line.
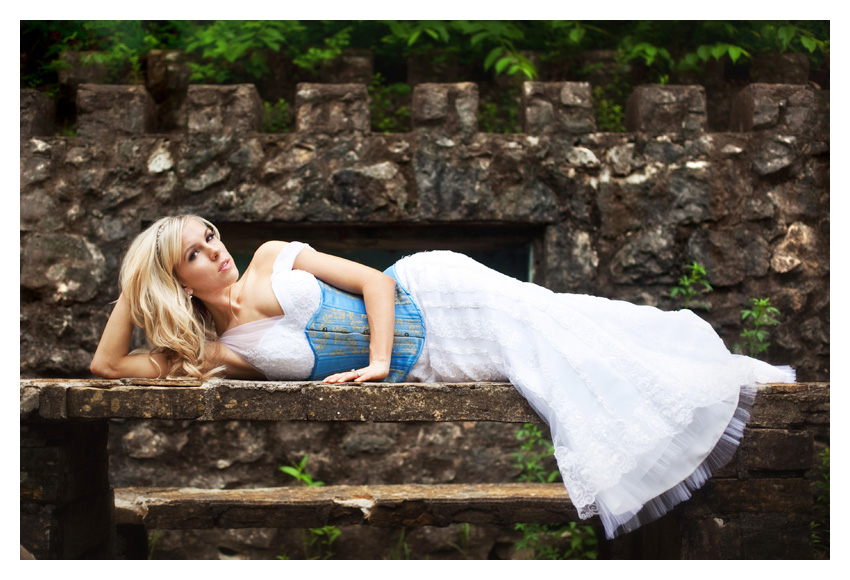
left=175, top=219, right=239, bottom=299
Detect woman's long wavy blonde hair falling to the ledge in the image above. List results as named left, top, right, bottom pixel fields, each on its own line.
left=120, top=215, right=223, bottom=379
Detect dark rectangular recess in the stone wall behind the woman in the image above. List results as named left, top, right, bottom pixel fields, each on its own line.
left=216, top=222, right=543, bottom=282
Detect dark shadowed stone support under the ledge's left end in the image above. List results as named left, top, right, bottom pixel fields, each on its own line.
left=20, top=420, right=115, bottom=560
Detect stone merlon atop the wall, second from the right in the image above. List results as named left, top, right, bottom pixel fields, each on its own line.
left=626, top=85, right=708, bottom=141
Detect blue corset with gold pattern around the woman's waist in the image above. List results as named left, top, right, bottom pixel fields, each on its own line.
left=306, top=266, right=425, bottom=383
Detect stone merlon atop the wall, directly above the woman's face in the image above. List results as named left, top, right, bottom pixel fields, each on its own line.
left=186, top=85, right=263, bottom=135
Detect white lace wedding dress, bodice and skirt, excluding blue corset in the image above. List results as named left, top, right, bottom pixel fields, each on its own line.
left=220, top=242, right=794, bottom=537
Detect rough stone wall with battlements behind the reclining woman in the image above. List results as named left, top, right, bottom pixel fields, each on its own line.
left=20, top=65, right=830, bottom=555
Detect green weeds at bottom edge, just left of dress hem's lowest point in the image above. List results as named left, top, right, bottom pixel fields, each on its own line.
left=514, top=522, right=599, bottom=560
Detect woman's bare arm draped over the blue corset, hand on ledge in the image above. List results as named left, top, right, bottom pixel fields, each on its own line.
left=294, top=250, right=395, bottom=383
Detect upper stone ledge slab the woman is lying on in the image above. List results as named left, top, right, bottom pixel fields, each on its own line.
left=20, top=379, right=829, bottom=429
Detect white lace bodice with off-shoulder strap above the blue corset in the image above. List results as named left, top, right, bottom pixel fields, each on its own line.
left=219, top=242, right=322, bottom=381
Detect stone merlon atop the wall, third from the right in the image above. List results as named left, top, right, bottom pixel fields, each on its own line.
left=520, top=82, right=596, bottom=135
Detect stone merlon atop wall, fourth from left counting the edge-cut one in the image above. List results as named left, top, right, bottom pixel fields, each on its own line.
left=295, top=83, right=371, bottom=135
